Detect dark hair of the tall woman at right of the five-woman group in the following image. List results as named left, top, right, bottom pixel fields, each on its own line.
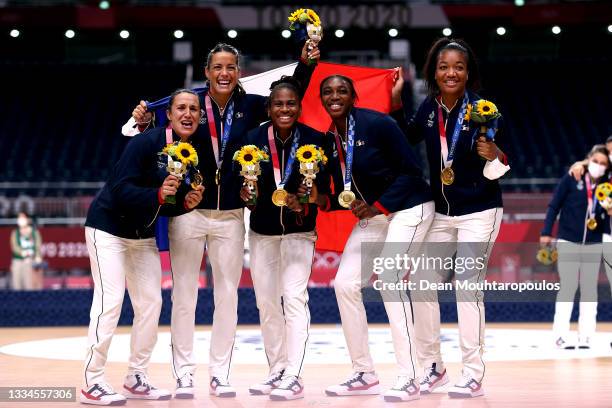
left=423, top=37, right=480, bottom=97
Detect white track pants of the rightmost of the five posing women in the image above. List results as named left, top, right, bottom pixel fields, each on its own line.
left=412, top=208, right=503, bottom=381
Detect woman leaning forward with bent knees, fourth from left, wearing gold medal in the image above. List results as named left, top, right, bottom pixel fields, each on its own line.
left=320, top=75, right=434, bottom=401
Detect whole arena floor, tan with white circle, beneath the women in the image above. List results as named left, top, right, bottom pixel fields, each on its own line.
left=0, top=323, right=612, bottom=408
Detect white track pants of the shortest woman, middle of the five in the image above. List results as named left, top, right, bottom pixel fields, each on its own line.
left=249, top=230, right=317, bottom=377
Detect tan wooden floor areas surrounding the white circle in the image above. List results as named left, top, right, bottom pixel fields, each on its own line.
left=0, top=323, right=612, bottom=408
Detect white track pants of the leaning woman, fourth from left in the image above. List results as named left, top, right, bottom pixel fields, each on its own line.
left=334, top=202, right=434, bottom=378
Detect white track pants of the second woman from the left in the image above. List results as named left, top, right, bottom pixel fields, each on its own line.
left=169, top=209, right=244, bottom=381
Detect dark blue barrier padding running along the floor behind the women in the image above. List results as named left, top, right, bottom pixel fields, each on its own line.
left=0, top=288, right=612, bottom=327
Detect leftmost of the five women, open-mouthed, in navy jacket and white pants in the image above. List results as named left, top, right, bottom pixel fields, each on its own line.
left=79, top=89, right=204, bottom=405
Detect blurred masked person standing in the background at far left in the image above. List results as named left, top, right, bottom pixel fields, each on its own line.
left=10, top=212, right=41, bottom=290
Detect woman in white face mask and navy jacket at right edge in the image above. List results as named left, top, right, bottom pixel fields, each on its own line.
left=540, top=145, right=610, bottom=348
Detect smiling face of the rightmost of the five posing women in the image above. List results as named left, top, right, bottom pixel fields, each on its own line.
left=435, top=49, right=468, bottom=96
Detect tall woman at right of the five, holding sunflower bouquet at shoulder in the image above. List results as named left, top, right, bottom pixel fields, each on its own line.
left=393, top=38, right=510, bottom=397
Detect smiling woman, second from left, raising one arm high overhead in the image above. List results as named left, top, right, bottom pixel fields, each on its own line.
left=122, top=43, right=319, bottom=399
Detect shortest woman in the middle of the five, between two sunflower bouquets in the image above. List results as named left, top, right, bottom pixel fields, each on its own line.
left=236, top=77, right=330, bottom=400
